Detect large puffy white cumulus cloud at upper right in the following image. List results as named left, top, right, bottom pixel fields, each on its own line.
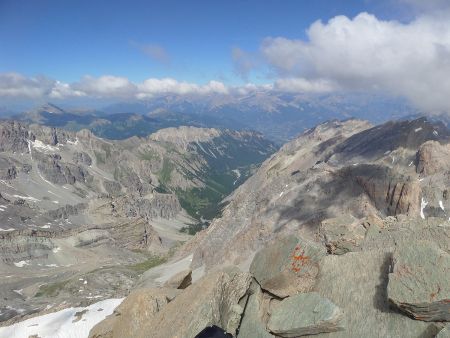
left=261, top=13, right=450, bottom=111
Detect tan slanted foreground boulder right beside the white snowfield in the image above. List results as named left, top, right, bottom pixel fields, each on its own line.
left=89, top=288, right=180, bottom=338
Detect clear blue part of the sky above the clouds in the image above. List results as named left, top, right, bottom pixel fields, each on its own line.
left=0, top=0, right=398, bottom=84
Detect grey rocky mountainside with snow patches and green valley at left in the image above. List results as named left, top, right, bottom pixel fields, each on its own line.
left=0, top=121, right=275, bottom=321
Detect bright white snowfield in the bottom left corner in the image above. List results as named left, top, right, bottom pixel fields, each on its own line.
left=0, top=298, right=123, bottom=338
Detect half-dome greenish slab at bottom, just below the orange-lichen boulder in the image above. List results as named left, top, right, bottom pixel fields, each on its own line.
left=267, top=292, right=345, bottom=337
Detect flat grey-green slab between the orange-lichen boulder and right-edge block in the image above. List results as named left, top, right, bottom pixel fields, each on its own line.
left=310, top=251, right=438, bottom=338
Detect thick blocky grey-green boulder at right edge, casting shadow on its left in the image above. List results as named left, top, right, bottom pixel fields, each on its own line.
left=387, top=241, right=450, bottom=321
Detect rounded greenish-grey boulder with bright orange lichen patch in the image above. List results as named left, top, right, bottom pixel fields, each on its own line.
left=250, top=236, right=325, bottom=298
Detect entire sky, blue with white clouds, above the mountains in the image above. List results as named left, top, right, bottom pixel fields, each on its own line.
left=0, top=0, right=450, bottom=111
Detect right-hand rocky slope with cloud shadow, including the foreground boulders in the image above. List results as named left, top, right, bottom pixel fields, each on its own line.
left=84, top=118, right=450, bottom=338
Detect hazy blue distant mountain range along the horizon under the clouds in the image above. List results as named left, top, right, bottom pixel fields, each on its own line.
left=14, top=91, right=419, bottom=144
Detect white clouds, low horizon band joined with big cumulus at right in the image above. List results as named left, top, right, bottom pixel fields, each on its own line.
left=0, top=9, right=450, bottom=113
